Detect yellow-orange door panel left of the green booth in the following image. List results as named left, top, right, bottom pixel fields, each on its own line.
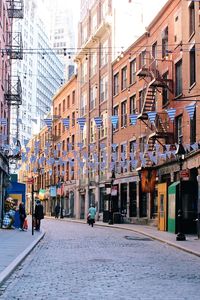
left=158, top=183, right=167, bottom=231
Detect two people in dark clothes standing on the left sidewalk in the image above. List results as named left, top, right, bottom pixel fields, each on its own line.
left=19, top=199, right=44, bottom=231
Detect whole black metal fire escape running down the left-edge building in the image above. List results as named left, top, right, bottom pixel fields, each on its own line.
left=4, top=0, right=24, bottom=160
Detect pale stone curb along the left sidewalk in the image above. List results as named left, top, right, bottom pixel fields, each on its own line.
left=0, top=232, right=45, bottom=287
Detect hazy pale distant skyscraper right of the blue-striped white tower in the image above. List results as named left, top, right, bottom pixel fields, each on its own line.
left=44, top=0, right=78, bottom=80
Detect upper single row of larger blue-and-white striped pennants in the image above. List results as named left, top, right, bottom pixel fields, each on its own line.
left=44, top=103, right=196, bottom=131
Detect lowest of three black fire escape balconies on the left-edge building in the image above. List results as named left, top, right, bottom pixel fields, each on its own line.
left=4, top=76, right=22, bottom=106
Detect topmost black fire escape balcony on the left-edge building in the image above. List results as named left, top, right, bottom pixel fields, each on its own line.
left=6, top=0, right=24, bottom=19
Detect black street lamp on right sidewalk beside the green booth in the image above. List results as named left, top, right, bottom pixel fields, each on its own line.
left=175, top=141, right=186, bottom=241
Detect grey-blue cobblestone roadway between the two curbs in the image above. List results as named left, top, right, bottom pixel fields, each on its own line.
left=0, top=220, right=200, bottom=300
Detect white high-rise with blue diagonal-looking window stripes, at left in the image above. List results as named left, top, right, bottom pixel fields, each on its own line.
left=11, top=0, right=63, bottom=149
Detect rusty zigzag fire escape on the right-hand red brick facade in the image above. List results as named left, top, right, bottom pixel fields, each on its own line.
left=137, top=54, right=173, bottom=166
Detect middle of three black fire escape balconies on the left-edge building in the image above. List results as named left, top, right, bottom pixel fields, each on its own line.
left=6, top=32, right=23, bottom=59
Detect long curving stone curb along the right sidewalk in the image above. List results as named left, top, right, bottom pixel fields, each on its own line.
left=47, top=217, right=200, bottom=257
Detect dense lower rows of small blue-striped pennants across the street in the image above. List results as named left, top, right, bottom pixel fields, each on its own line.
left=12, top=141, right=200, bottom=175
